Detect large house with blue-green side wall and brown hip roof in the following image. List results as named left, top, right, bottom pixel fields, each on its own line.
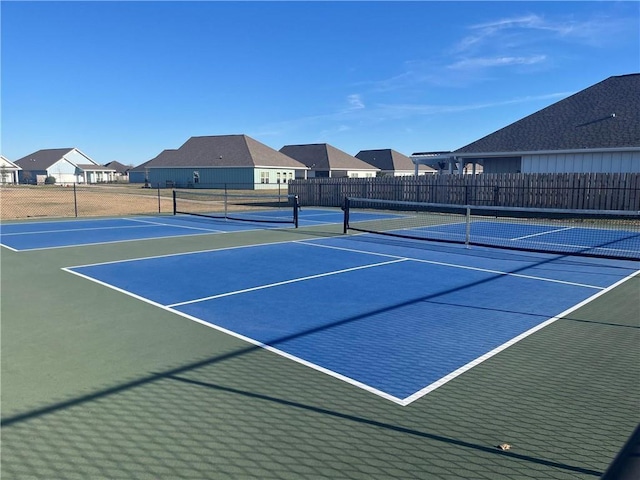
left=132, top=135, right=307, bottom=189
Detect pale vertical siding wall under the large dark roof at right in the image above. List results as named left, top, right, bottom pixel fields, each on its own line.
left=522, top=151, right=640, bottom=173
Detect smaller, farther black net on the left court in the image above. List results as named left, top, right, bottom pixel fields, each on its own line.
left=173, top=190, right=299, bottom=228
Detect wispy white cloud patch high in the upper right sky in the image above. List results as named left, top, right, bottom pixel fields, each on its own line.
left=360, top=9, right=637, bottom=93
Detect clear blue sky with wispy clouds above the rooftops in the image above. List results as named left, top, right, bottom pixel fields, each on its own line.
left=0, top=0, right=640, bottom=165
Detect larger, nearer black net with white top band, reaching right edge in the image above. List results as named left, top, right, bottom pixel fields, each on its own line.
left=344, top=197, right=640, bottom=260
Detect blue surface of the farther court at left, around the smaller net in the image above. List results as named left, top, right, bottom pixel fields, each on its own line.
left=0, top=208, right=392, bottom=251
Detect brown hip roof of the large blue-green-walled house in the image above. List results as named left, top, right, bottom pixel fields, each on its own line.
left=144, top=135, right=306, bottom=170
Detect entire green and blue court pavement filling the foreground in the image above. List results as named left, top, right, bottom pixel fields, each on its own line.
left=0, top=196, right=640, bottom=479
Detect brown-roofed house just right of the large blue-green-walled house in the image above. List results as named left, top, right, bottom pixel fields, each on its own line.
left=280, top=143, right=380, bottom=178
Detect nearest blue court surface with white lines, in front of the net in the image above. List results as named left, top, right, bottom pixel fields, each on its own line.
left=64, top=235, right=640, bottom=405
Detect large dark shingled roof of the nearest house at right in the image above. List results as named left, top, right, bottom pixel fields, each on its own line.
left=455, top=73, right=640, bottom=153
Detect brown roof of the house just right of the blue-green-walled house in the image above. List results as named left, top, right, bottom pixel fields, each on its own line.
left=280, top=143, right=379, bottom=171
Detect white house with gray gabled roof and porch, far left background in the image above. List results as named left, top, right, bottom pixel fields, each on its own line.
left=15, top=148, right=115, bottom=185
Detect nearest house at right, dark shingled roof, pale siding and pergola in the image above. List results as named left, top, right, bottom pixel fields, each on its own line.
left=411, top=73, right=640, bottom=173
